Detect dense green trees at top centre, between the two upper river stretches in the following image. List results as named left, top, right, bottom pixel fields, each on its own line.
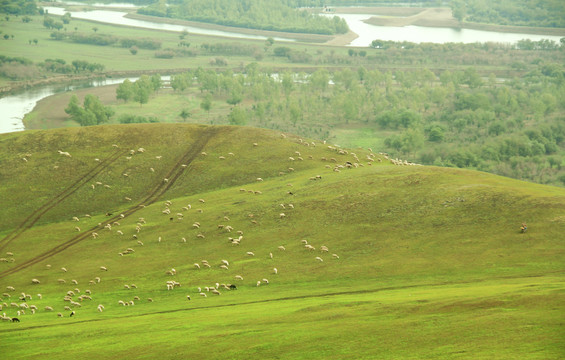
left=138, top=0, right=348, bottom=34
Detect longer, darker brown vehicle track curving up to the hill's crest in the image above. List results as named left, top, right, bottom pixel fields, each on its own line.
left=0, top=128, right=218, bottom=279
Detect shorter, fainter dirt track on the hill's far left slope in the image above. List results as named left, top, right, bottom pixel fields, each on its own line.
left=0, top=150, right=127, bottom=250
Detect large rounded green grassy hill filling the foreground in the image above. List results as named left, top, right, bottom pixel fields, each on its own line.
left=0, top=124, right=565, bottom=359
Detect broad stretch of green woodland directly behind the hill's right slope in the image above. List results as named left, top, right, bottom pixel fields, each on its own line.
left=161, top=63, right=565, bottom=185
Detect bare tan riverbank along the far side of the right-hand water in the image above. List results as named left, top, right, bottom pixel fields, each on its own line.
left=356, top=8, right=565, bottom=36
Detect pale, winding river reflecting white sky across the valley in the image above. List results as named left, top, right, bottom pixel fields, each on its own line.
left=0, top=4, right=560, bottom=133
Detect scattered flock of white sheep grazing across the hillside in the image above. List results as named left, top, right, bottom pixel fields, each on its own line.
left=0, top=131, right=412, bottom=322
